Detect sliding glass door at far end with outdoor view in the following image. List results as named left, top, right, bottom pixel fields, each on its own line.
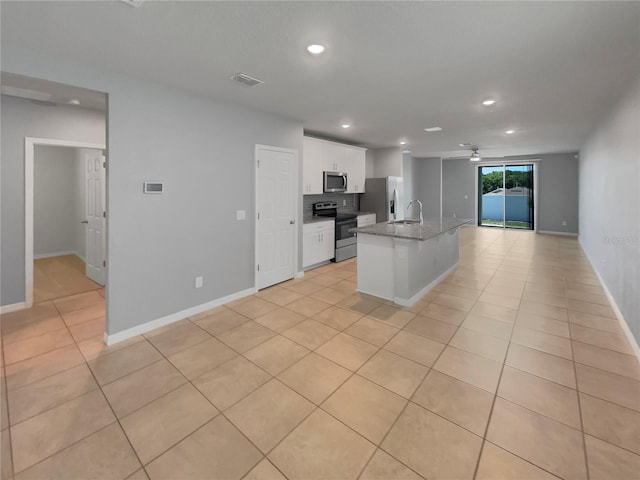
left=478, top=164, right=534, bottom=230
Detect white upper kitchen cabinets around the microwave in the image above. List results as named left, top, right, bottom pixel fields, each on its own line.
left=302, top=137, right=366, bottom=195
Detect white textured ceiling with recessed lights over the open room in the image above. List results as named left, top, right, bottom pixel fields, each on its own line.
left=1, top=1, right=640, bottom=157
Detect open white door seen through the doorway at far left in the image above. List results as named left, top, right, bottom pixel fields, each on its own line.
left=84, top=150, right=106, bottom=285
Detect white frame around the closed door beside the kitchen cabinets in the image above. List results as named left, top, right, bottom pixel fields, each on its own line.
left=253, top=143, right=300, bottom=291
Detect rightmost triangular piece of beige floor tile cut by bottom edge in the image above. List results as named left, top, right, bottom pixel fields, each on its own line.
left=475, top=442, right=558, bottom=480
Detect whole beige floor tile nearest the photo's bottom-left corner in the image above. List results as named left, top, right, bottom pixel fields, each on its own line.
left=11, top=390, right=115, bottom=473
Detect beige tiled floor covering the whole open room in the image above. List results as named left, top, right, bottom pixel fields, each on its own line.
left=1, top=228, right=640, bottom=480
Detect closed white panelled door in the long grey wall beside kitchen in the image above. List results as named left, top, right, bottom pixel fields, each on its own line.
left=256, top=146, right=297, bottom=289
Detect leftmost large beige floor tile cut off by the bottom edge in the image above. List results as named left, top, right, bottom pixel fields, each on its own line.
left=16, top=423, right=141, bottom=480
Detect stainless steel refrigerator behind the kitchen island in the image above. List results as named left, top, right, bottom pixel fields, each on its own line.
left=360, top=177, right=405, bottom=223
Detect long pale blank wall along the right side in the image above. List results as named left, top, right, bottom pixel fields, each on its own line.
left=580, top=74, right=640, bottom=343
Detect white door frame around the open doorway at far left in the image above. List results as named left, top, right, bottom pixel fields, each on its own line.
left=24, top=137, right=108, bottom=308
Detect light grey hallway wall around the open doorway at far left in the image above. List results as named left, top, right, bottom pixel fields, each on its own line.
left=0, top=94, right=106, bottom=305
